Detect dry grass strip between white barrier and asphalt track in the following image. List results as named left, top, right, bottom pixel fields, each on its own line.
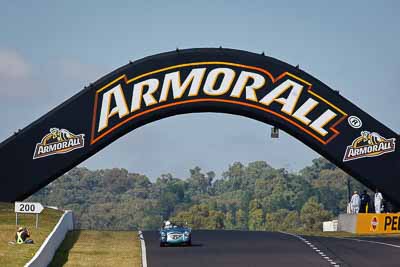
left=50, top=230, right=142, bottom=267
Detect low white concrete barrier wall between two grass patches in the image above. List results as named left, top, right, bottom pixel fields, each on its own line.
left=25, top=211, right=74, bottom=267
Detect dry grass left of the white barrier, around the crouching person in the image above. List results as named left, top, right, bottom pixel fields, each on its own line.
left=0, top=203, right=63, bottom=267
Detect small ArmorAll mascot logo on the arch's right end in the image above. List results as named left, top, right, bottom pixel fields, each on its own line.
left=343, top=131, right=396, bottom=161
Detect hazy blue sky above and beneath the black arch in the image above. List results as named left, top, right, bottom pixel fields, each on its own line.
left=0, top=0, right=400, bottom=180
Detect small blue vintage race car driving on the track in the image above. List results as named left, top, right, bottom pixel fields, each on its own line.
left=160, top=221, right=192, bottom=247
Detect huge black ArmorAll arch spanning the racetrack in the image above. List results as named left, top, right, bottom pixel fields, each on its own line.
left=0, top=48, right=400, bottom=205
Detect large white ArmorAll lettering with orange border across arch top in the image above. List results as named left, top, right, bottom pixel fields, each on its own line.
left=90, top=62, right=347, bottom=145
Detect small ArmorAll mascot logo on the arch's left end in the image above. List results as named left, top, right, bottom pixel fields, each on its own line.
left=33, top=128, right=85, bottom=159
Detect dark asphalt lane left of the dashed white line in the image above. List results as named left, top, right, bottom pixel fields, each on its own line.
left=144, top=231, right=332, bottom=267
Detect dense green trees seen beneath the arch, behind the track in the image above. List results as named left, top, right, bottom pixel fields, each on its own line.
left=31, top=158, right=363, bottom=231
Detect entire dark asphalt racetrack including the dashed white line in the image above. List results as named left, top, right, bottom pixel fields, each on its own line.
left=144, top=231, right=400, bottom=267
